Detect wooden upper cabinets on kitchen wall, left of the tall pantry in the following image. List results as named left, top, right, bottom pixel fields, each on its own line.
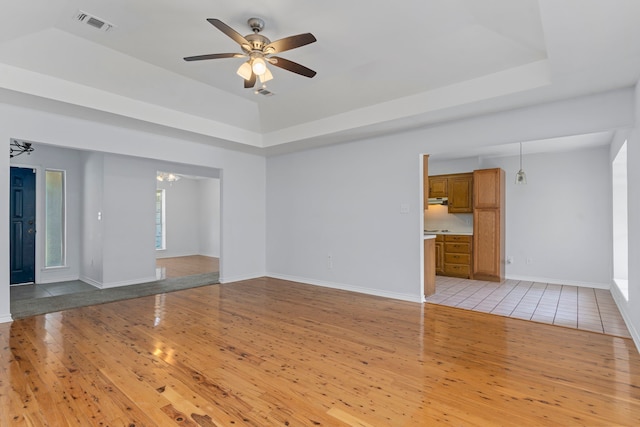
left=429, top=173, right=473, bottom=213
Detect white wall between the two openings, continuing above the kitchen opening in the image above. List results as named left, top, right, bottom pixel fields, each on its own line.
left=267, top=89, right=634, bottom=301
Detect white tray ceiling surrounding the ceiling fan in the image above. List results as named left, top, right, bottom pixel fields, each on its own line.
left=0, top=0, right=640, bottom=155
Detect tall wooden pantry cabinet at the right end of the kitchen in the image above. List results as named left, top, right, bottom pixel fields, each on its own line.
left=473, top=168, right=505, bottom=282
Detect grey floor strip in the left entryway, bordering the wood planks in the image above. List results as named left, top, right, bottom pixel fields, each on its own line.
left=11, top=272, right=220, bottom=319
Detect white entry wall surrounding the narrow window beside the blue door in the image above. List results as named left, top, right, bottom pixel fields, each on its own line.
left=10, top=146, right=83, bottom=283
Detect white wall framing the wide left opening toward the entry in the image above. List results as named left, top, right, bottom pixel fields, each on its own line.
left=0, top=99, right=266, bottom=321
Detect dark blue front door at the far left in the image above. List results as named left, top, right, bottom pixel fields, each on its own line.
left=9, top=167, right=36, bottom=285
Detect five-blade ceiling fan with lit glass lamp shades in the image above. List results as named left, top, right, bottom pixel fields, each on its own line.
left=184, top=18, right=316, bottom=88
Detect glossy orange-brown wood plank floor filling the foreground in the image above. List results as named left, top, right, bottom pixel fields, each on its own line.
left=0, top=278, right=640, bottom=427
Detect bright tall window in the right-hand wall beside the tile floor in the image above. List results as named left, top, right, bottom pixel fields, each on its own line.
left=611, top=141, right=629, bottom=301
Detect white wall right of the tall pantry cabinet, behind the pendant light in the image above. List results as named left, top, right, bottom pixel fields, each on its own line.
left=483, top=146, right=613, bottom=289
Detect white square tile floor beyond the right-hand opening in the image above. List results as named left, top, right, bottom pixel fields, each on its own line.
left=427, top=276, right=631, bottom=338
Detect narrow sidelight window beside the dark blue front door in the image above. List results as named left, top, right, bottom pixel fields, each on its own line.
left=44, top=170, right=66, bottom=268
